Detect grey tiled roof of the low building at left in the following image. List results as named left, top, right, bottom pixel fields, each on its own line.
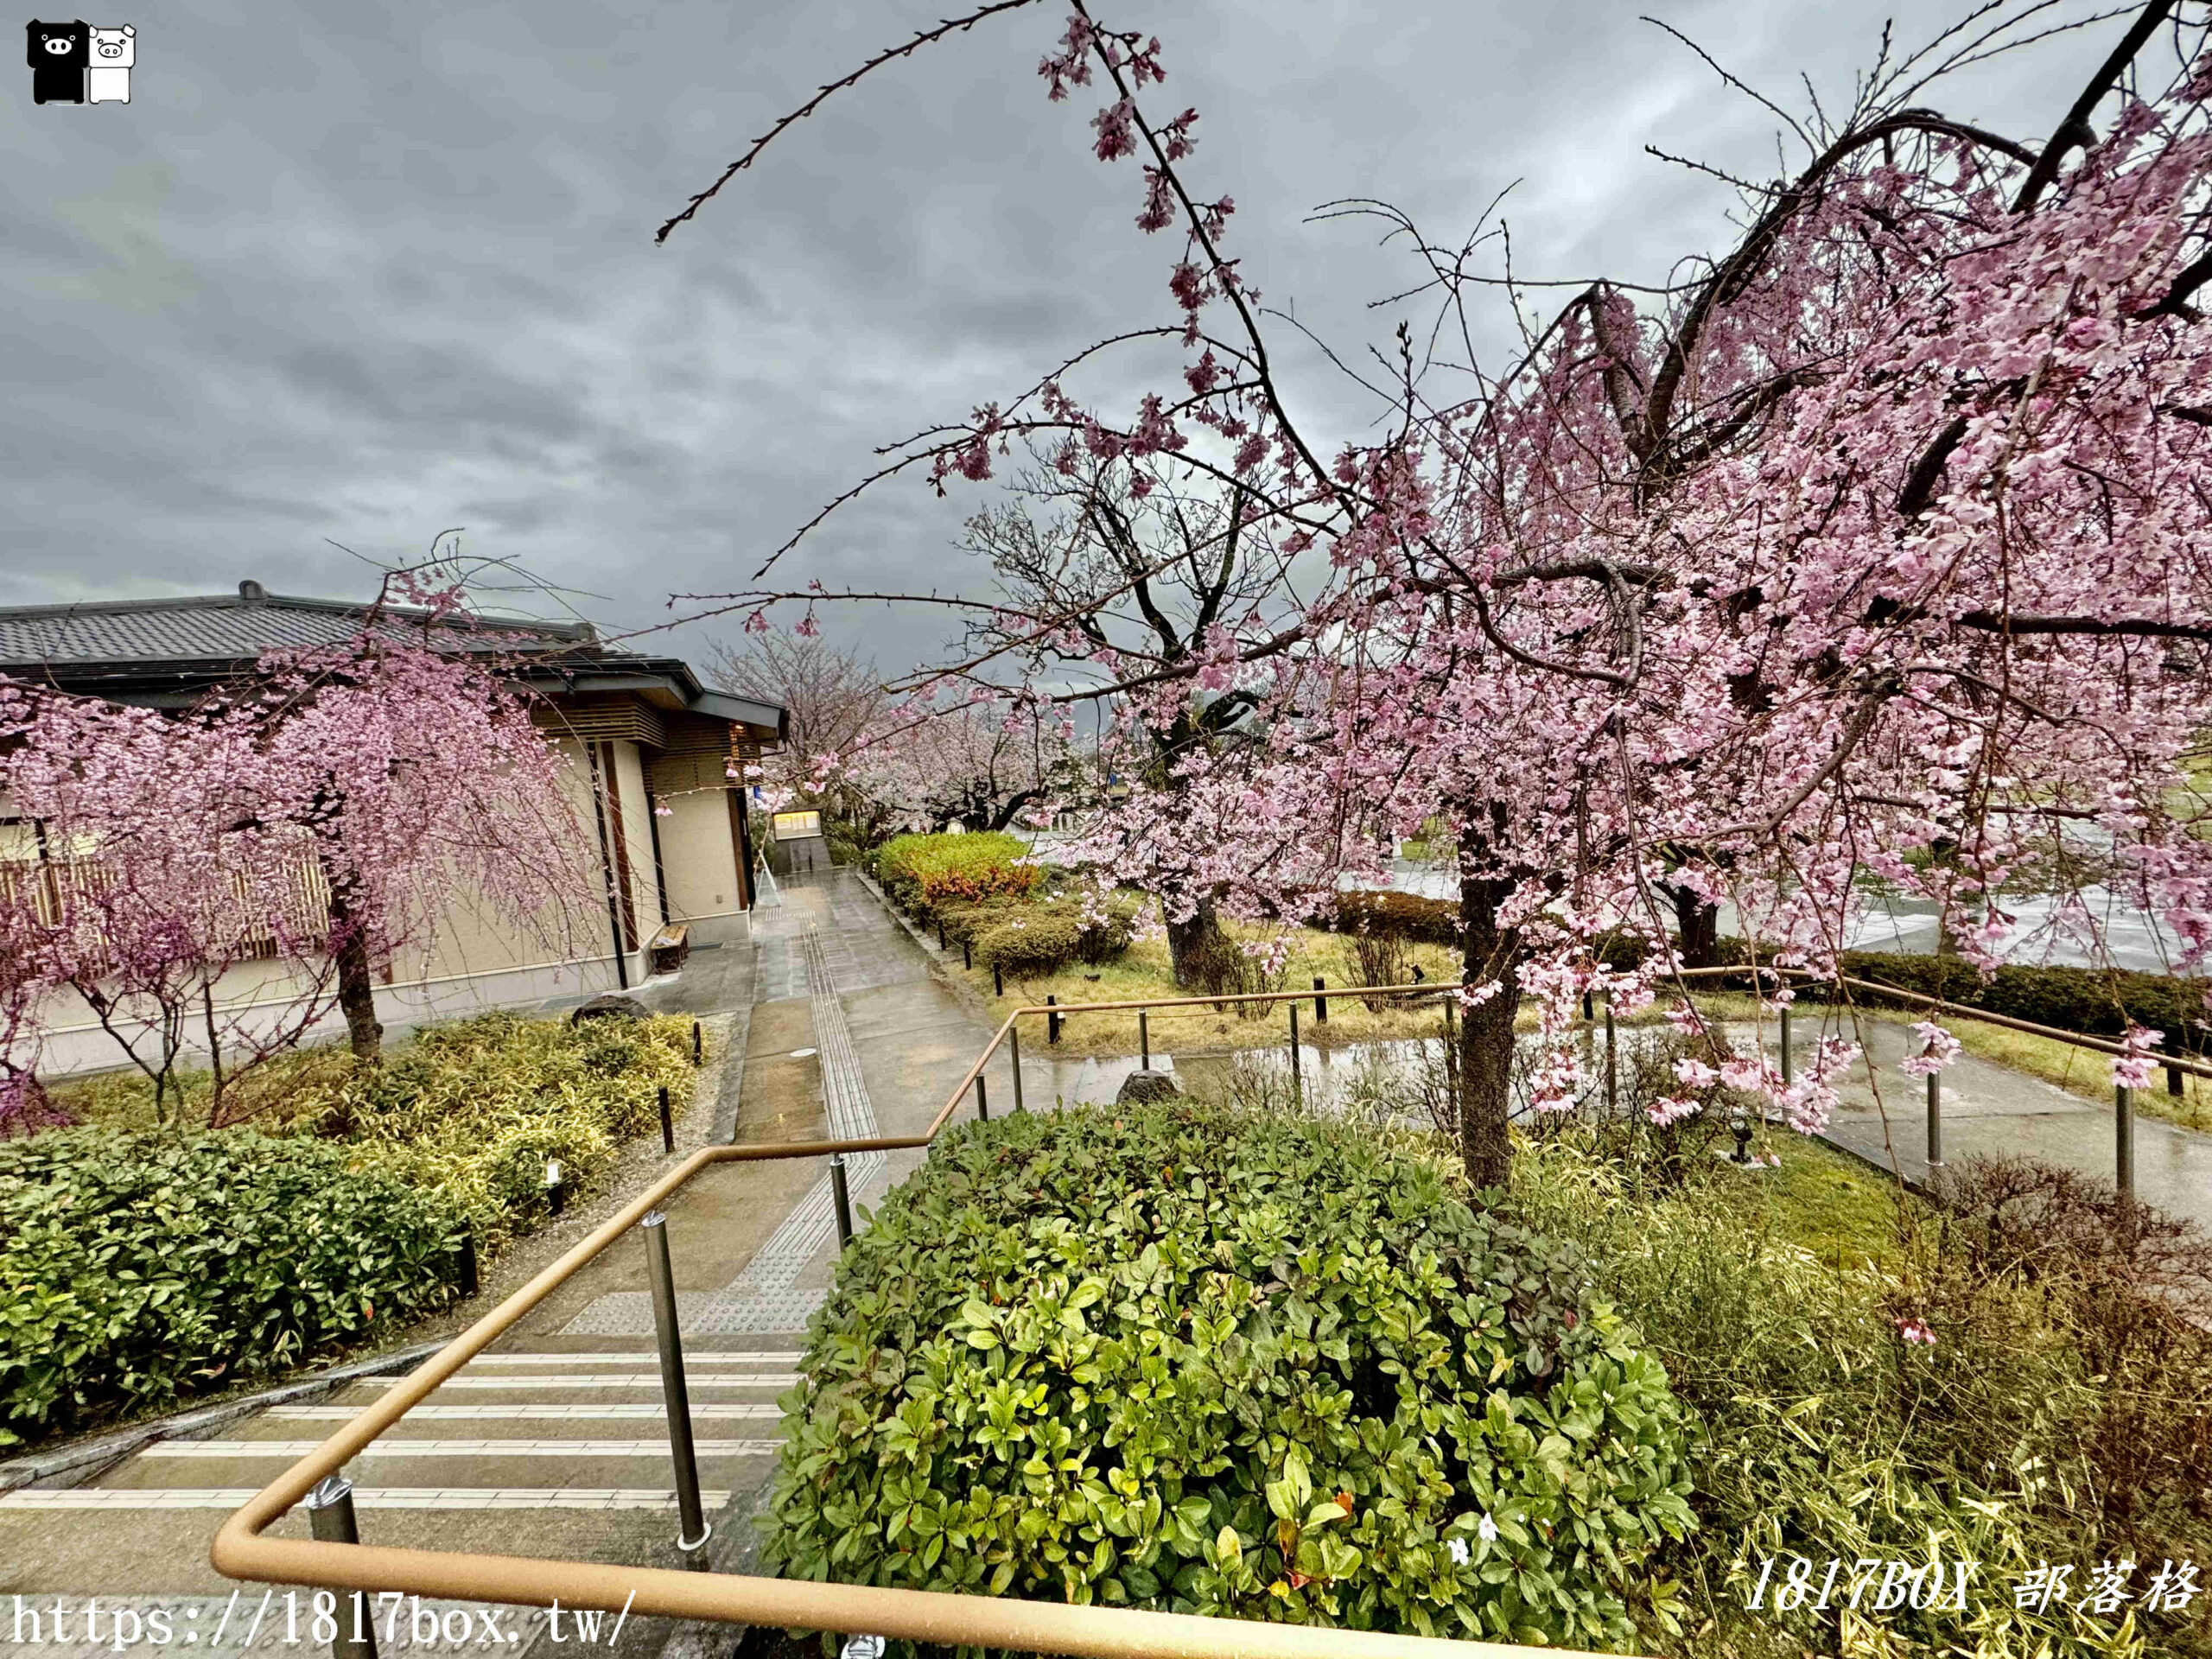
left=0, top=593, right=593, bottom=672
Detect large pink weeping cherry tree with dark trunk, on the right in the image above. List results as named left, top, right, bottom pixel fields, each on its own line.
left=661, top=0, right=2212, bottom=1184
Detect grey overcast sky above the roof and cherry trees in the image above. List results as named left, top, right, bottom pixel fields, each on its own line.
left=0, top=0, right=2121, bottom=671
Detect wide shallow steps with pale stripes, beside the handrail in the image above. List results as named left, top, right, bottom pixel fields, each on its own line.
left=0, top=1332, right=801, bottom=1659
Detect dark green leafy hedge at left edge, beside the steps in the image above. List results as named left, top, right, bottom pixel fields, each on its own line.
left=0, top=1128, right=462, bottom=1445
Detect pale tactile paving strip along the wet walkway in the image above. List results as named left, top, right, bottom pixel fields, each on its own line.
left=562, top=927, right=885, bottom=1336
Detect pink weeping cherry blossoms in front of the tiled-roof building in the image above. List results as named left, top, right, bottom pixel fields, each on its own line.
left=0, top=593, right=591, bottom=1117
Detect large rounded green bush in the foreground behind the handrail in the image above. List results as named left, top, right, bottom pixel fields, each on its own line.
left=767, top=1102, right=1694, bottom=1646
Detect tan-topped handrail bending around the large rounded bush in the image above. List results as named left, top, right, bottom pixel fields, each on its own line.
left=210, top=984, right=1597, bottom=1659
